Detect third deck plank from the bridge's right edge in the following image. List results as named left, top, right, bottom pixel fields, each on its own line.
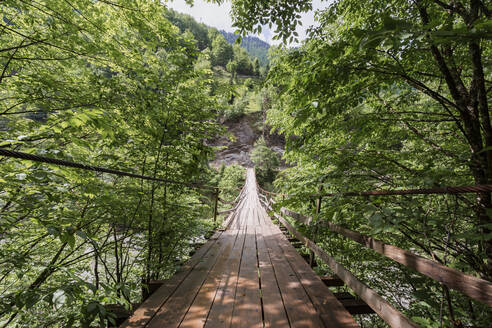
left=256, top=220, right=290, bottom=328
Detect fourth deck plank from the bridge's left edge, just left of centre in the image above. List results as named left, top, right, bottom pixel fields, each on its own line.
left=205, top=230, right=246, bottom=328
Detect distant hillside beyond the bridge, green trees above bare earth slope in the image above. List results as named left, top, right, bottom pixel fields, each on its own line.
left=166, top=10, right=284, bottom=172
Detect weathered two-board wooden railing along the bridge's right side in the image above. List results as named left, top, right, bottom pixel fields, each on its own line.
left=259, top=188, right=492, bottom=328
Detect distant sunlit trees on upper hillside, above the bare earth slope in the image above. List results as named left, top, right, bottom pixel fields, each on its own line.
left=165, top=10, right=269, bottom=120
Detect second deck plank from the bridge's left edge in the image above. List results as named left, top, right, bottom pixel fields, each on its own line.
left=147, top=231, right=235, bottom=328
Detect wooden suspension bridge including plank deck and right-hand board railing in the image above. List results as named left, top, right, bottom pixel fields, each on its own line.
left=120, top=169, right=492, bottom=328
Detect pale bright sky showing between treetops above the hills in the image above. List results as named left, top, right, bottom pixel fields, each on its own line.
left=166, top=0, right=331, bottom=44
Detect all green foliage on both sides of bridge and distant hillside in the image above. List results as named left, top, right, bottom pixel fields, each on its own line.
left=0, top=0, right=492, bottom=327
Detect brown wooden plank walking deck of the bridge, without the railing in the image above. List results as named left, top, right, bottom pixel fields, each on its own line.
left=121, top=169, right=358, bottom=328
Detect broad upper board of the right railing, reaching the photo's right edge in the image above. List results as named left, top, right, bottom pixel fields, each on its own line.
left=280, top=208, right=492, bottom=307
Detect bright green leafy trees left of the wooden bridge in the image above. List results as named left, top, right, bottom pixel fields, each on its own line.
left=0, top=0, right=230, bottom=327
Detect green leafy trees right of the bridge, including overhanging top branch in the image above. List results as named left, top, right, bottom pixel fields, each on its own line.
left=219, top=0, right=492, bottom=327
